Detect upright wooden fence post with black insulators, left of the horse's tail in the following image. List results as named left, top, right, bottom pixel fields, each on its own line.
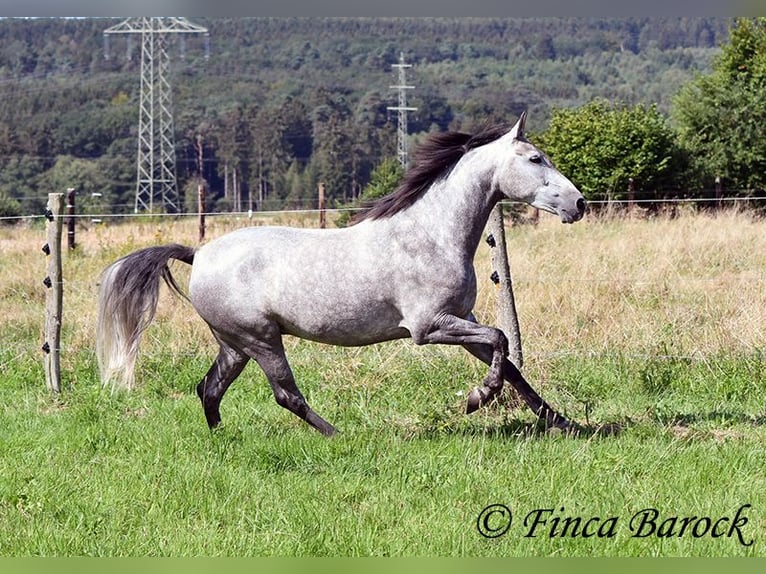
left=43, top=193, right=64, bottom=393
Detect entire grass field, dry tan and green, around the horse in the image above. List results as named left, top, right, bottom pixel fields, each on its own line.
left=0, top=208, right=766, bottom=556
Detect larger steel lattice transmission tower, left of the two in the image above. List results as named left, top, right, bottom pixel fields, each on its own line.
left=104, top=17, right=210, bottom=213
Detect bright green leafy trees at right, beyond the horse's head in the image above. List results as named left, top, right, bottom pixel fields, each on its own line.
left=541, top=17, right=766, bottom=207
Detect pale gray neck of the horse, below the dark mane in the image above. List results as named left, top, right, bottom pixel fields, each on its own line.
left=395, top=154, right=499, bottom=257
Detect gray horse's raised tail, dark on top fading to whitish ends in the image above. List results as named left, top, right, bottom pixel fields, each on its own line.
left=96, top=244, right=194, bottom=389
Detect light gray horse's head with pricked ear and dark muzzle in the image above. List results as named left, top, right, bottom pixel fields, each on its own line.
left=494, top=112, right=585, bottom=223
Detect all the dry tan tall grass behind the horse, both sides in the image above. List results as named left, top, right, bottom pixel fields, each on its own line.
left=0, top=207, right=766, bottom=374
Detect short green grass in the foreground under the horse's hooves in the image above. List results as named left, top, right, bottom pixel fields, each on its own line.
left=0, top=342, right=766, bottom=556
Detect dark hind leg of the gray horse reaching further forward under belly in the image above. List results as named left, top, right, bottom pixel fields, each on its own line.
left=251, top=336, right=335, bottom=436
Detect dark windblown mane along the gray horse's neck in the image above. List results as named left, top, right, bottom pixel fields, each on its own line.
left=351, top=123, right=512, bottom=224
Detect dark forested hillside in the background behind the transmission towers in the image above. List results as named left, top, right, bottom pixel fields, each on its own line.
left=0, top=18, right=731, bottom=216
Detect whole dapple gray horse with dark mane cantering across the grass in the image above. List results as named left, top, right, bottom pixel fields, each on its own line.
left=96, top=112, right=586, bottom=436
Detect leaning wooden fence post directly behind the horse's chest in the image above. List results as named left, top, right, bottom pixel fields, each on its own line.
left=487, top=203, right=524, bottom=369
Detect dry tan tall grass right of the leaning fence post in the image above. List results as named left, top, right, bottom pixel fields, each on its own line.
left=498, top=207, right=766, bottom=356
